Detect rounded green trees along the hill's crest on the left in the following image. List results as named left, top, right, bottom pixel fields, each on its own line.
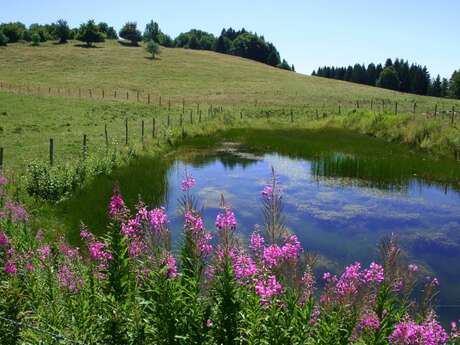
left=0, top=19, right=295, bottom=71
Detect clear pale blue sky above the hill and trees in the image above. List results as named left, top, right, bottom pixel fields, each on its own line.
left=0, top=0, right=460, bottom=77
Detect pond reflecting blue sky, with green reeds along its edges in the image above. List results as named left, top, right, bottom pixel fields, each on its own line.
left=59, top=129, right=460, bottom=320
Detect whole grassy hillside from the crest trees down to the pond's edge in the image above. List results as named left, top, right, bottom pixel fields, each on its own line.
left=0, top=41, right=460, bottom=171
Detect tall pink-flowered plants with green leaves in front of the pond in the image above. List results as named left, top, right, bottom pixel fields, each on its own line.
left=0, top=172, right=460, bottom=345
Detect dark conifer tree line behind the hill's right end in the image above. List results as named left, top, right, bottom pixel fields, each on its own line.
left=312, top=58, right=460, bottom=99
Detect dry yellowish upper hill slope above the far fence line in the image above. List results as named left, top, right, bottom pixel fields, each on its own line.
left=0, top=41, right=458, bottom=110
